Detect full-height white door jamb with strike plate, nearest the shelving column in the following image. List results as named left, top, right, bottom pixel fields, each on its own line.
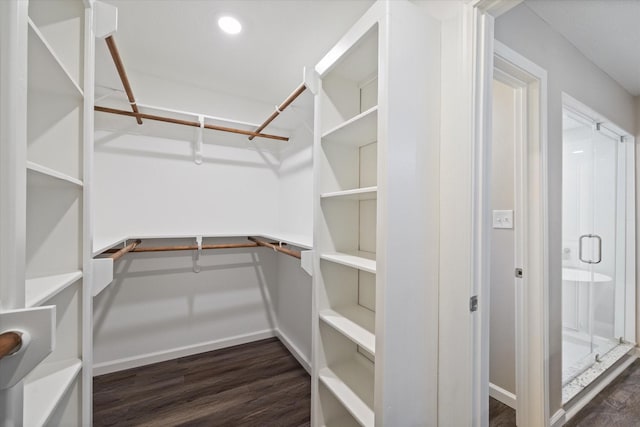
left=465, top=1, right=501, bottom=427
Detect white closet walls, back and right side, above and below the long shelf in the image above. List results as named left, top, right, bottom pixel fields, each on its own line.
left=94, top=76, right=313, bottom=373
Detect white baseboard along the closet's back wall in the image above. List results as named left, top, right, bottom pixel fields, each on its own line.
left=93, top=329, right=276, bottom=376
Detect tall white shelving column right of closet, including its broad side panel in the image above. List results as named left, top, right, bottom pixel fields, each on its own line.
left=312, top=0, right=440, bottom=426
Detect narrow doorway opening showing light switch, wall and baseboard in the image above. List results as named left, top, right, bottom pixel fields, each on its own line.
left=489, top=77, right=522, bottom=421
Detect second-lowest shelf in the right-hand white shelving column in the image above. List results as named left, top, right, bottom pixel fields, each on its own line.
left=320, top=305, right=376, bottom=355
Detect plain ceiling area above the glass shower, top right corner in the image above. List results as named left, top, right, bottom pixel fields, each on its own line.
left=526, top=0, right=640, bottom=96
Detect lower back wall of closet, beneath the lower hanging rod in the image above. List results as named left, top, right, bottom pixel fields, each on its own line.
left=94, top=239, right=278, bottom=374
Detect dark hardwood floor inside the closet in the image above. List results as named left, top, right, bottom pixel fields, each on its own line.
left=93, top=338, right=311, bottom=427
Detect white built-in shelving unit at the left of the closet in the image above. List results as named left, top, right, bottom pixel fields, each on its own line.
left=2, top=0, right=93, bottom=427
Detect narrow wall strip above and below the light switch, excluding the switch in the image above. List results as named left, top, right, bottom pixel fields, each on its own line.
left=489, top=80, right=520, bottom=395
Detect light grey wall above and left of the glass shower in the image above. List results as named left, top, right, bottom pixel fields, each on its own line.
left=495, top=4, right=636, bottom=414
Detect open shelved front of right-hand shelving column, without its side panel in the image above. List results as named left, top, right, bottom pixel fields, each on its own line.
left=314, top=10, right=378, bottom=426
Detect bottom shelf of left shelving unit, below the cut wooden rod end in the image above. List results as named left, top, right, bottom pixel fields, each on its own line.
left=24, top=359, right=82, bottom=427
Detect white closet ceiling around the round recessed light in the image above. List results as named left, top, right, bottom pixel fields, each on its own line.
left=96, top=0, right=373, bottom=104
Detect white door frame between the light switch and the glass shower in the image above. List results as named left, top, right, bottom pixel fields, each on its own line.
left=492, top=41, right=549, bottom=426
